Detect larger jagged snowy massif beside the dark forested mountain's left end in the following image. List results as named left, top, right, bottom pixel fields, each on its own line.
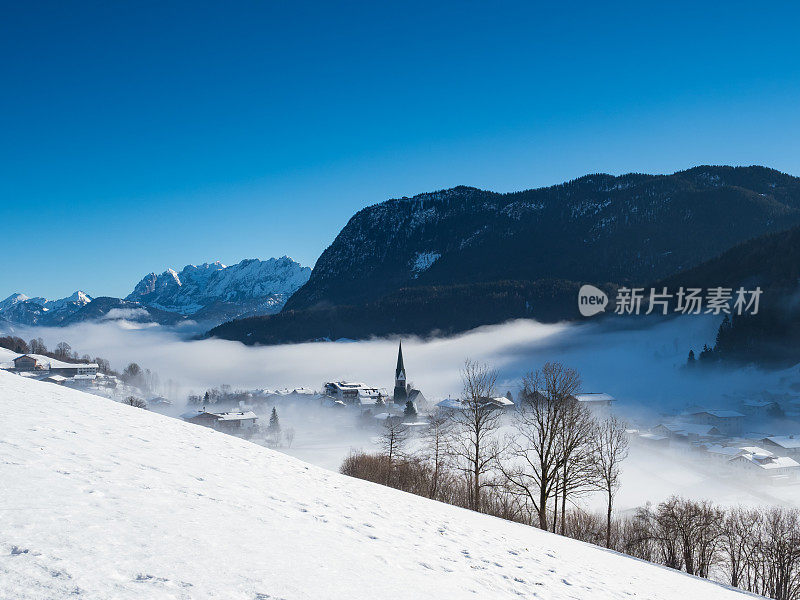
left=126, top=256, right=311, bottom=316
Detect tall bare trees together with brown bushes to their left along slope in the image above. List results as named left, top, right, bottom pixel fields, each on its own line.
left=342, top=360, right=627, bottom=545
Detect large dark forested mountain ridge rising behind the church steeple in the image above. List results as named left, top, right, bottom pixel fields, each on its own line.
left=209, top=165, right=800, bottom=343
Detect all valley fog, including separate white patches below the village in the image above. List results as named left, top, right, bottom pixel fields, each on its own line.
left=6, top=316, right=800, bottom=508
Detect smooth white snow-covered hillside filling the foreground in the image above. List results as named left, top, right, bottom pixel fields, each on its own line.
left=0, top=372, right=752, bottom=600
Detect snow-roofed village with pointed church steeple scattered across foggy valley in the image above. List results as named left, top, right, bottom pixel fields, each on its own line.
left=0, top=343, right=800, bottom=485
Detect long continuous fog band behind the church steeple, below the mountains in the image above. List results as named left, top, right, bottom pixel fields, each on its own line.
left=3, top=317, right=788, bottom=411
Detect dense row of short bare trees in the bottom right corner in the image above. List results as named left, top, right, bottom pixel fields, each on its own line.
left=565, top=496, right=800, bottom=600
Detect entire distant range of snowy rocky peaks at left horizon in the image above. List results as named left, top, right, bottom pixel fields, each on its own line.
left=0, top=256, right=311, bottom=326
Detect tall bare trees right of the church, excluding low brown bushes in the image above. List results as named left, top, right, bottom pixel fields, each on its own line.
left=454, top=361, right=628, bottom=545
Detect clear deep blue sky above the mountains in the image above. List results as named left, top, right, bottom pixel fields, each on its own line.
left=0, top=0, right=800, bottom=297
